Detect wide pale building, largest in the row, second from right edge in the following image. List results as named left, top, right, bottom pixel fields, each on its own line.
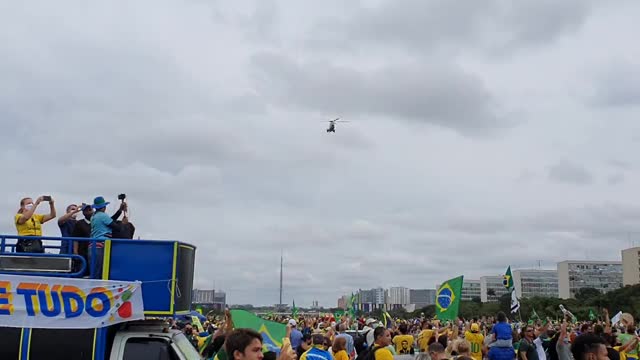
left=558, top=260, right=622, bottom=299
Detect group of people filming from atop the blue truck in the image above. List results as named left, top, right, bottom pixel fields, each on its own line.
left=14, top=194, right=135, bottom=278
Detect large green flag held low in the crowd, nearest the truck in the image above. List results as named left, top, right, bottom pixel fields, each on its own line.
left=231, top=310, right=287, bottom=354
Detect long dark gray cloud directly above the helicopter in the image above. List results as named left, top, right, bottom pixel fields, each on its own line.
left=253, top=53, right=510, bottom=134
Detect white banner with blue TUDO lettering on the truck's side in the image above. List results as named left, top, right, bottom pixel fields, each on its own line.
left=0, top=274, right=144, bottom=329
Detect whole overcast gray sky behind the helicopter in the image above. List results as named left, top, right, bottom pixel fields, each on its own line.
left=0, top=0, right=640, bottom=306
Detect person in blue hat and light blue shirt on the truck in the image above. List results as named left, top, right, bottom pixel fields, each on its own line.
left=89, top=196, right=117, bottom=279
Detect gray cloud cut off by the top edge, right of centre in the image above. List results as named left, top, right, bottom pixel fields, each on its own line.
left=311, top=0, right=592, bottom=54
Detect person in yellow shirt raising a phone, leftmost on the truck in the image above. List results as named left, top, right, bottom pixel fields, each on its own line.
left=14, top=196, right=56, bottom=253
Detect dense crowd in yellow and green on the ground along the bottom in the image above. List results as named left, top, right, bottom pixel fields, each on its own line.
left=182, top=311, right=640, bottom=360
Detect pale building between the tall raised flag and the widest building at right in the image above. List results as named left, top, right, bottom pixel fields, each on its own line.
left=503, top=269, right=559, bottom=298
